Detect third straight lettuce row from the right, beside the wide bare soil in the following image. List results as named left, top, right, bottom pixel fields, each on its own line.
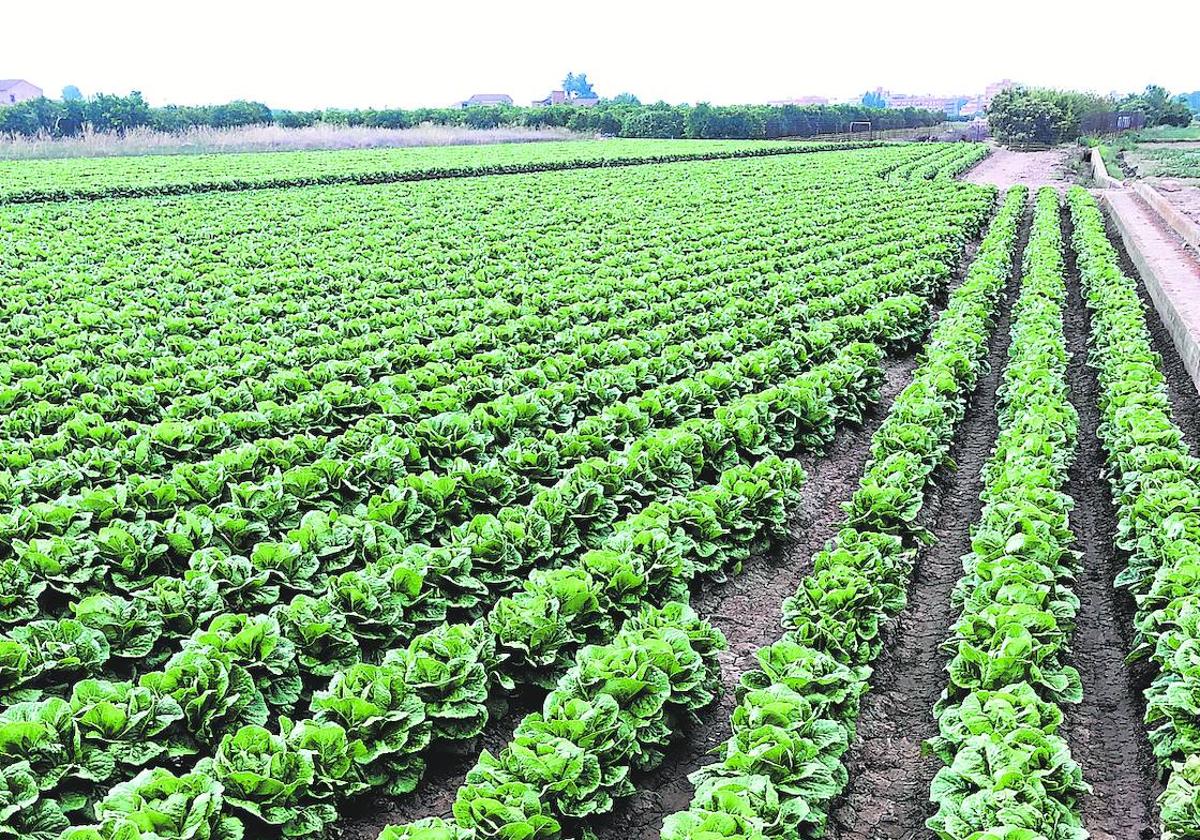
left=643, top=187, right=1026, bottom=840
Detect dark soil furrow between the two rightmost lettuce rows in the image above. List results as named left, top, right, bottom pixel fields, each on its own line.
left=1063, top=212, right=1161, bottom=840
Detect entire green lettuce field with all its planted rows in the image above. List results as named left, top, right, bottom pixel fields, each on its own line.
left=0, top=140, right=1200, bottom=840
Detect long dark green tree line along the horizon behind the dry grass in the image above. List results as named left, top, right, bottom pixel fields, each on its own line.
left=0, top=91, right=946, bottom=139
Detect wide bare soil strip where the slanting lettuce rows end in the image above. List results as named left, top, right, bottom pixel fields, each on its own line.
left=593, top=356, right=916, bottom=840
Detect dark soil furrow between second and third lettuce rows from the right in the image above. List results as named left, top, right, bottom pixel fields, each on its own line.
left=829, top=200, right=1032, bottom=840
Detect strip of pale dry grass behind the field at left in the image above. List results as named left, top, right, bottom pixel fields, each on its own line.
left=0, top=124, right=593, bottom=160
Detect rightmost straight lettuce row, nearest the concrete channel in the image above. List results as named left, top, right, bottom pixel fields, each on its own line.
left=1069, top=188, right=1200, bottom=840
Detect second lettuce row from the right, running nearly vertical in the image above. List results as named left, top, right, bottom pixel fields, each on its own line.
left=928, top=187, right=1090, bottom=840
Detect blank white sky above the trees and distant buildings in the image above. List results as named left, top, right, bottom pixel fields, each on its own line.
left=9, top=0, right=1200, bottom=108
